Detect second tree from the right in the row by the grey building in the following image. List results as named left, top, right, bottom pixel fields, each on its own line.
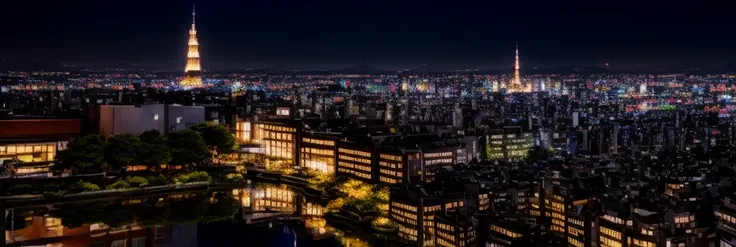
left=166, top=129, right=212, bottom=165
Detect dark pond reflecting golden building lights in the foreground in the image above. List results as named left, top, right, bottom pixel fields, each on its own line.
left=5, top=184, right=380, bottom=247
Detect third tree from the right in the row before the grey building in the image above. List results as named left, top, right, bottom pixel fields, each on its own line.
left=139, top=130, right=171, bottom=167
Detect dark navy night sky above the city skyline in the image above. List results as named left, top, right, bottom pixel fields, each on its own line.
left=0, top=0, right=736, bottom=68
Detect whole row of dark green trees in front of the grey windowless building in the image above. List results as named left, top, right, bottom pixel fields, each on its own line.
left=53, top=123, right=236, bottom=173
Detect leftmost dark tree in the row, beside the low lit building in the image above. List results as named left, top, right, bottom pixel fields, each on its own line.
left=53, top=134, right=105, bottom=173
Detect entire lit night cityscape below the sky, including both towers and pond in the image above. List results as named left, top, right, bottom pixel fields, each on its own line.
left=0, top=3, right=736, bottom=247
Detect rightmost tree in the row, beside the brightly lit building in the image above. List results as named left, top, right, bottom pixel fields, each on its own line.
left=190, top=122, right=236, bottom=155
